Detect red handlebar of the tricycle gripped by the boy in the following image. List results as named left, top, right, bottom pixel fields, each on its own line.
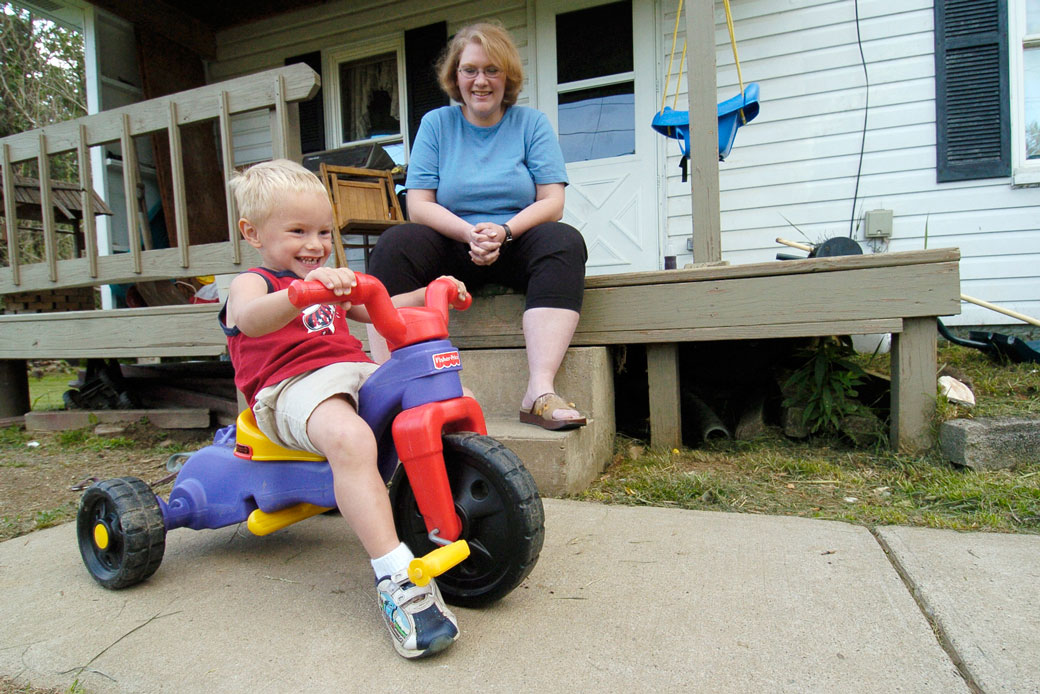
left=288, top=273, right=473, bottom=350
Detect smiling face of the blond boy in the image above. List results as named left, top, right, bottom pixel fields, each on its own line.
left=239, top=191, right=333, bottom=277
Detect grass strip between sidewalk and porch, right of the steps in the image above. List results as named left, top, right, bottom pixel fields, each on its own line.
left=577, top=345, right=1040, bottom=533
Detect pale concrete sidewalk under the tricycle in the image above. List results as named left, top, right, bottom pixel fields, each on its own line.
left=0, top=499, right=1040, bottom=694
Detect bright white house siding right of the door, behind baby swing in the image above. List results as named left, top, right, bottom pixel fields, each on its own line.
left=662, top=0, right=1040, bottom=325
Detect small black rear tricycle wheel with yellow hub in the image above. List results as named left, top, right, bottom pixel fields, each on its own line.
left=76, top=478, right=166, bottom=590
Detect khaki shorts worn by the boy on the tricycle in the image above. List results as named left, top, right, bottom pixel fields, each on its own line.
left=253, top=361, right=379, bottom=456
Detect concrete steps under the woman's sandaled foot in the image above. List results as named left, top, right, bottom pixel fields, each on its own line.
left=461, top=346, right=616, bottom=496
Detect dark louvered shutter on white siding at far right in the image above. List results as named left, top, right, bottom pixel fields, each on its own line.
left=935, top=0, right=1011, bottom=183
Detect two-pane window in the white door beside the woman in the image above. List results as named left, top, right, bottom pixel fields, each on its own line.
left=556, top=0, right=635, bottom=163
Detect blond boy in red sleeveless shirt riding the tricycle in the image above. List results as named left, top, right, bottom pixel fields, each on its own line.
left=220, top=159, right=465, bottom=658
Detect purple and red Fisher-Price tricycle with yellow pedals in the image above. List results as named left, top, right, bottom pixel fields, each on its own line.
left=77, top=273, right=545, bottom=607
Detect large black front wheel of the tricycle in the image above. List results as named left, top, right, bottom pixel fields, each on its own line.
left=390, top=433, right=545, bottom=607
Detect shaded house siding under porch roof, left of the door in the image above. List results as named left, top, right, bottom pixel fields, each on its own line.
left=209, top=0, right=534, bottom=164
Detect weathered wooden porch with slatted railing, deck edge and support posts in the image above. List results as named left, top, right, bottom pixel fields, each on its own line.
left=0, top=65, right=960, bottom=448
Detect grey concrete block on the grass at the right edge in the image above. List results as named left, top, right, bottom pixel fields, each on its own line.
left=939, top=417, right=1040, bottom=470
